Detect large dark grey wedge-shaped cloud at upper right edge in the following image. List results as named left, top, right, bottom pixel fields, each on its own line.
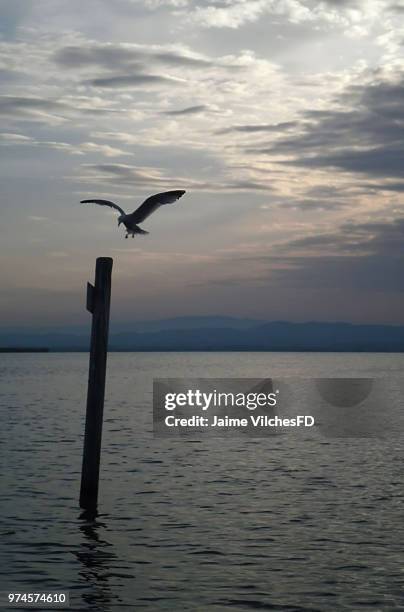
left=249, top=72, right=404, bottom=178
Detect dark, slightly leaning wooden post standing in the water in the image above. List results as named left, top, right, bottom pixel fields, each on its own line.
left=80, top=257, right=112, bottom=510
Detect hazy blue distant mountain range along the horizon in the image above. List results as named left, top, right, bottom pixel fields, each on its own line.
left=0, top=317, right=404, bottom=352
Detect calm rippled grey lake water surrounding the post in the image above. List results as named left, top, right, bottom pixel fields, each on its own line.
left=0, top=353, right=404, bottom=612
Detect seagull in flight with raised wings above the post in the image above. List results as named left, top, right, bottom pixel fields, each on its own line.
left=80, top=189, right=185, bottom=238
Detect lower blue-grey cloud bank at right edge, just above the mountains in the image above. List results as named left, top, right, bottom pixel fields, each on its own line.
left=229, top=217, right=404, bottom=294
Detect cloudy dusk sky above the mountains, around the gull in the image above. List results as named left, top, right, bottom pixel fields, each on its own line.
left=0, top=0, right=404, bottom=327
